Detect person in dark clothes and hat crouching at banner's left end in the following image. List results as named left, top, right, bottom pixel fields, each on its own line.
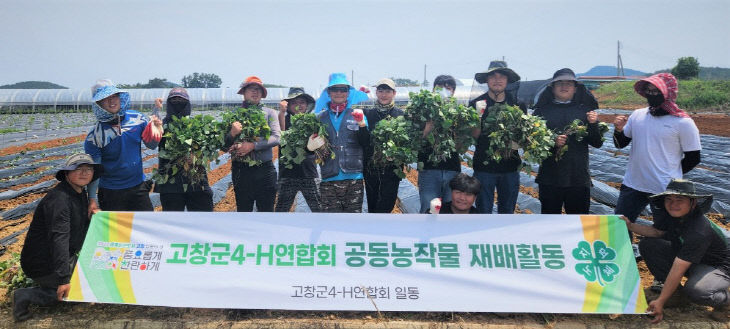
left=12, top=153, right=103, bottom=321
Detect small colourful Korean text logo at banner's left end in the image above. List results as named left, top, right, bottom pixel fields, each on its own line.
left=91, top=241, right=162, bottom=271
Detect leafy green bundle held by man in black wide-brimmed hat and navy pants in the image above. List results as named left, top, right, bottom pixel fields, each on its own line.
left=482, top=104, right=555, bottom=164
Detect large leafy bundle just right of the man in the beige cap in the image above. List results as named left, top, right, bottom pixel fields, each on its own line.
left=405, top=90, right=479, bottom=168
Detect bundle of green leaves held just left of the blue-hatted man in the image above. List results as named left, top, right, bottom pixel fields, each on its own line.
left=279, top=113, right=335, bottom=169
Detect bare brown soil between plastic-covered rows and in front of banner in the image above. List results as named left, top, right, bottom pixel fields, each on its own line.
left=0, top=130, right=730, bottom=328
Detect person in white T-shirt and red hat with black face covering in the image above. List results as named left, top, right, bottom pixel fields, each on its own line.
left=613, top=73, right=702, bottom=258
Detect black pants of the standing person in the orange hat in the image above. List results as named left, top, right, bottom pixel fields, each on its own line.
left=231, top=161, right=276, bottom=212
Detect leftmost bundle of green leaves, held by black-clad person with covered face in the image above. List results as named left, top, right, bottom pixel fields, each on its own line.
left=154, top=115, right=225, bottom=191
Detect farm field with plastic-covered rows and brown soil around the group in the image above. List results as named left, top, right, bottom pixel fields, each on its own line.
left=0, top=112, right=730, bottom=328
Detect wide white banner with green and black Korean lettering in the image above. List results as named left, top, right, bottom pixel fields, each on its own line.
left=68, top=212, right=647, bottom=314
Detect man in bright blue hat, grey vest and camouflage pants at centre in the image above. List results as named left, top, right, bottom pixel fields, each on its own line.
left=308, top=73, right=370, bottom=212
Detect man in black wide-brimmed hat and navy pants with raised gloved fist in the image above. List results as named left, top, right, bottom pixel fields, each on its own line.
left=469, top=61, right=527, bottom=214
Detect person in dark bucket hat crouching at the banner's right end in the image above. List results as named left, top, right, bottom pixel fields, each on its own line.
left=621, top=179, right=730, bottom=323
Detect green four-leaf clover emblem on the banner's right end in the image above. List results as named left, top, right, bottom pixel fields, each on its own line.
left=573, top=240, right=619, bottom=286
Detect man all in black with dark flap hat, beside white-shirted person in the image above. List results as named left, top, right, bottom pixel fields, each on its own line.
left=532, top=68, right=603, bottom=214
